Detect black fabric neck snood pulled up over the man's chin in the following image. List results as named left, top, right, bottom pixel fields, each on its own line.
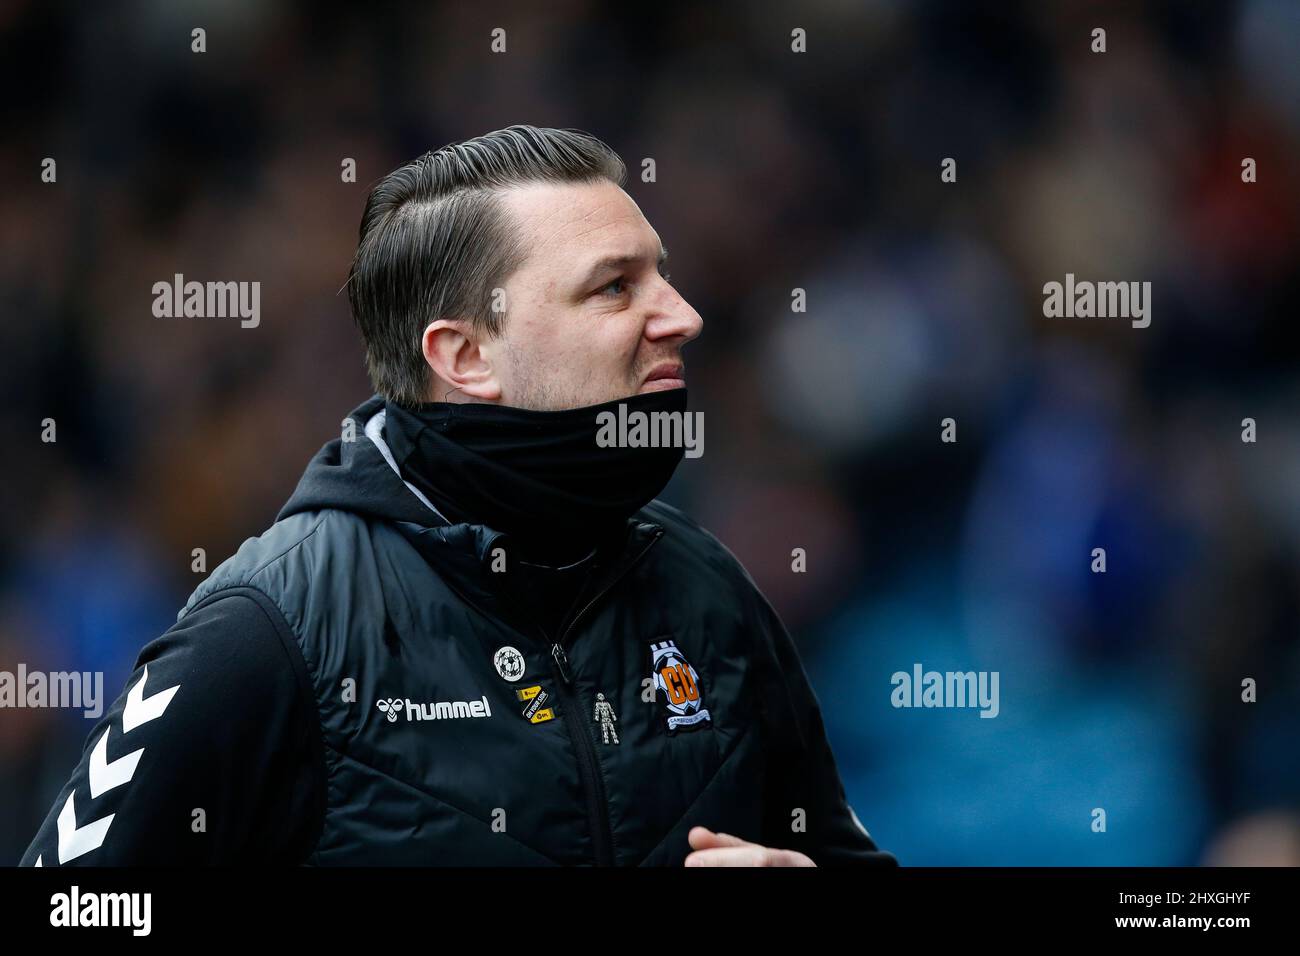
left=384, top=389, right=686, bottom=563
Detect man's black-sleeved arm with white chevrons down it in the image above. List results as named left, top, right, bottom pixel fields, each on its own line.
left=20, top=588, right=324, bottom=866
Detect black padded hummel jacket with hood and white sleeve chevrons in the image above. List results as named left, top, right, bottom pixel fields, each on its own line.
left=23, top=397, right=894, bottom=866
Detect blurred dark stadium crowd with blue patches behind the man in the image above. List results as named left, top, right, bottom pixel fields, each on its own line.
left=0, top=0, right=1300, bottom=865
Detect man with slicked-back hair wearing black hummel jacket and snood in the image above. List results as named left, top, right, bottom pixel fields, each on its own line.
left=23, top=126, right=896, bottom=866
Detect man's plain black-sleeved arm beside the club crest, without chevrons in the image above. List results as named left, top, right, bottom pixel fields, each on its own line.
left=754, top=588, right=898, bottom=866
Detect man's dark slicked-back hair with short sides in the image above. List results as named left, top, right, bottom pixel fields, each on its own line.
left=347, top=126, right=627, bottom=407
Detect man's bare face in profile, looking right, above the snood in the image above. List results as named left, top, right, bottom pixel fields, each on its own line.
left=480, top=181, right=703, bottom=410
